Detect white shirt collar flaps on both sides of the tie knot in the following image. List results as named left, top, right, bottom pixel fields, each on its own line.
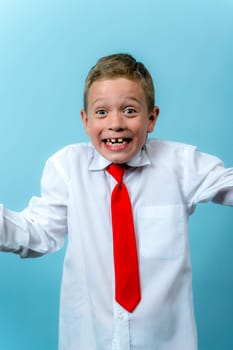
left=89, top=146, right=151, bottom=171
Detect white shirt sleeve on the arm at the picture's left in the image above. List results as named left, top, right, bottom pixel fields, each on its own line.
left=0, top=156, right=68, bottom=257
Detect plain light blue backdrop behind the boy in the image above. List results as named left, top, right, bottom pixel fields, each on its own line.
left=0, top=0, right=233, bottom=350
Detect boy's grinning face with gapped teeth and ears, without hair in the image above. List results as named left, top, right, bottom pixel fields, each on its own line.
left=81, top=78, right=159, bottom=163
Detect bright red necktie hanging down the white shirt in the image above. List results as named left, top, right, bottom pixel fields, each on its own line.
left=107, top=164, right=141, bottom=312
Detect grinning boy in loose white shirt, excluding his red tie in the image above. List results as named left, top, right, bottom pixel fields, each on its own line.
left=0, top=54, right=233, bottom=350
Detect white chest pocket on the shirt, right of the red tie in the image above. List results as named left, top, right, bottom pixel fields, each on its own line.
left=136, top=205, right=185, bottom=259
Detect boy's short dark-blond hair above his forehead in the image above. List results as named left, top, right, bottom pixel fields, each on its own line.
left=83, top=53, right=155, bottom=112
